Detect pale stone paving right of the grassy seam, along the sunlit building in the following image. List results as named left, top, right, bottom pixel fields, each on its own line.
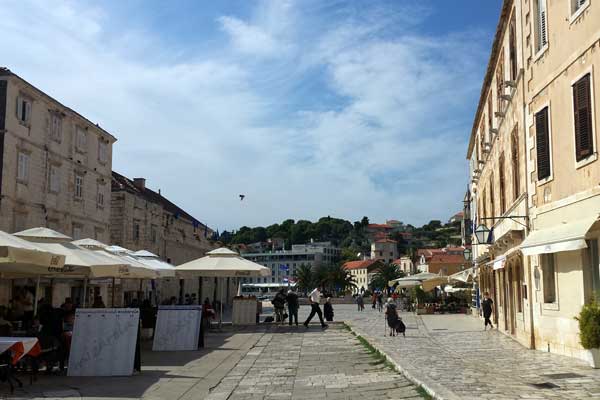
left=322, top=305, right=600, bottom=400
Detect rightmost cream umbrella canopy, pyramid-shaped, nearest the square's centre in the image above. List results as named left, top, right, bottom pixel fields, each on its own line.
left=175, top=247, right=271, bottom=278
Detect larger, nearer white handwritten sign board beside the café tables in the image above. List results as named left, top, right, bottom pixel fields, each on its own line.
left=68, top=308, right=140, bottom=376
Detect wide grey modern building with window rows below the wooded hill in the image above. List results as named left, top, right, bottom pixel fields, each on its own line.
left=242, top=242, right=342, bottom=283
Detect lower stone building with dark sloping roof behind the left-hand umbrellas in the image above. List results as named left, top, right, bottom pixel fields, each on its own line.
left=110, top=172, right=215, bottom=298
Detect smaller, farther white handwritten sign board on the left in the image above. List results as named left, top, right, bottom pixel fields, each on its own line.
left=152, top=306, right=202, bottom=351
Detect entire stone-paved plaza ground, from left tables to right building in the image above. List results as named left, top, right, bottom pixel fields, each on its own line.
left=0, top=305, right=600, bottom=400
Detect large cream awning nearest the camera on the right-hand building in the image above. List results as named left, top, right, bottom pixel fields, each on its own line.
left=521, top=215, right=598, bottom=256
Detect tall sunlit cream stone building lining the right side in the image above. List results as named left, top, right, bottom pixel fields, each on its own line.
left=466, top=0, right=600, bottom=358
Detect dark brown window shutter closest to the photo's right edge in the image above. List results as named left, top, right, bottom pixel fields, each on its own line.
left=573, top=74, right=594, bottom=161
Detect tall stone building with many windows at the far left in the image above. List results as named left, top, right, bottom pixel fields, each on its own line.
left=0, top=68, right=116, bottom=305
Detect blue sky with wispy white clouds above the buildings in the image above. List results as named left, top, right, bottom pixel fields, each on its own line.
left=0, top=0, right=501, bottom=230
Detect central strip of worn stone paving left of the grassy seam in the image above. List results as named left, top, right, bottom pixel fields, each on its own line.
left=206, top=324, right=421, bottom=400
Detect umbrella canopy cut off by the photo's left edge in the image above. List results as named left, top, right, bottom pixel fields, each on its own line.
left=0, top=231, right=65, bottom=278
